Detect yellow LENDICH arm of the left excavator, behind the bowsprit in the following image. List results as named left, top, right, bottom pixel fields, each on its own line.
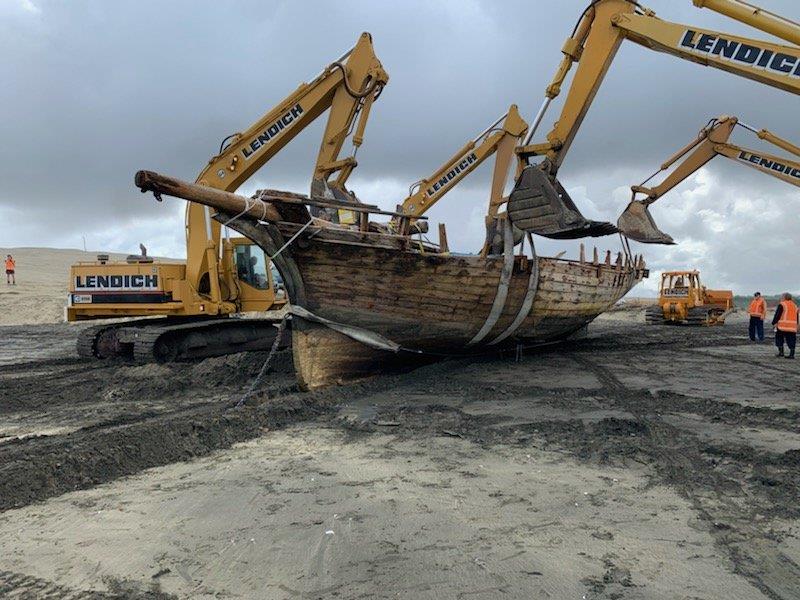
left=186, top=33, right=389, bottom=302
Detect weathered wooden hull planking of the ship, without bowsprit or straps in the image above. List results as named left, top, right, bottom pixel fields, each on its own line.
left=260, top=224, right=645, bottom=388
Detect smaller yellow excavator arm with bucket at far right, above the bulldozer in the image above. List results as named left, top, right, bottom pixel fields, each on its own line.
left=617, top=116, right=800, bottom=244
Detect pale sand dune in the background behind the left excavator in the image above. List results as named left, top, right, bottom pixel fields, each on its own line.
left=0, top=248, right=180, bottom=326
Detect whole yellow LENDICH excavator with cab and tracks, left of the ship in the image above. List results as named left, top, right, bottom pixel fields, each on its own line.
left=67, top=33, right=389, bottom=362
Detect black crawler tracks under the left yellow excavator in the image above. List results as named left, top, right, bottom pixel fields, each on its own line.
left=77, top=318, right=291, bottom=363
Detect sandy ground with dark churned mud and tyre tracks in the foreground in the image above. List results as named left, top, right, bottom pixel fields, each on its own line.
left=0, top=315, right=800, bottom=599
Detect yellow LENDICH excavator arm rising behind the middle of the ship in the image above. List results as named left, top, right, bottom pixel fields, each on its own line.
left=392, top=104, right=528, bottom=253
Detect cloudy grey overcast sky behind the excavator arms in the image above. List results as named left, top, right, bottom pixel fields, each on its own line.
left=0, top=0, right=800, bottom=293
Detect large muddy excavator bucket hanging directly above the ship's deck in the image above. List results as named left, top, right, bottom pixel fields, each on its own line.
left=507, top=165, right=617, bottom=240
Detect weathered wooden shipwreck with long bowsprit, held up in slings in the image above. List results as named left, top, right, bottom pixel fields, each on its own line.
left=137, top=172, right=647, bottom=389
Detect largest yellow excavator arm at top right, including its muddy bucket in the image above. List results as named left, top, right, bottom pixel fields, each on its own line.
left=507, top=0, right=800, bottom=239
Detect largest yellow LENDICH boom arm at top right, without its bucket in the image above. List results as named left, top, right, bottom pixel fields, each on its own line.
left=517, top=0, right=800, bottom=175
